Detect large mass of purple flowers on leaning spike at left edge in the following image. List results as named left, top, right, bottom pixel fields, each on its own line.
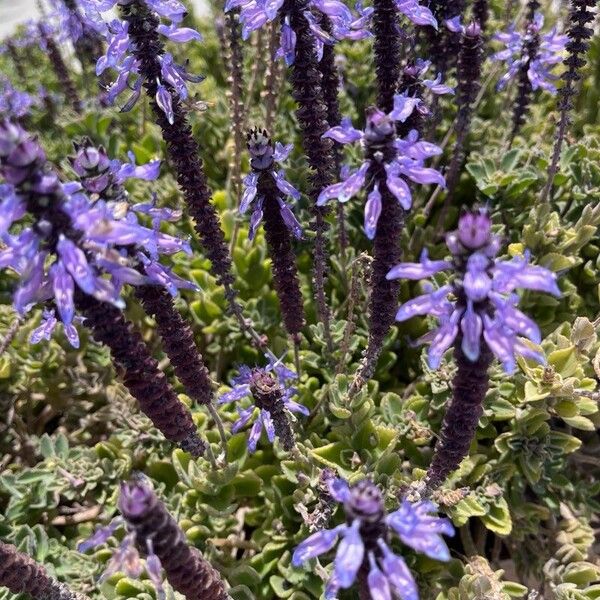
left=0, top=121, right=196, bottom=347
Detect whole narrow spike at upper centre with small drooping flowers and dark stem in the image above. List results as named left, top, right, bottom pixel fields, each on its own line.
left=240, top=129, right=304, bottom=346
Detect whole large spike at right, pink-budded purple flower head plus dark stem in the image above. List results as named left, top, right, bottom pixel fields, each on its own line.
left=388, top=210, right=560, bottom=490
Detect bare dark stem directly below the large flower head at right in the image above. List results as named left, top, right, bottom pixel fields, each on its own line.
left=425, top=339, right=493, bottom=494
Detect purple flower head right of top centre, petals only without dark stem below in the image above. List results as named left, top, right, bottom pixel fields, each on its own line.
left=317, top=106, right=445, bottom=239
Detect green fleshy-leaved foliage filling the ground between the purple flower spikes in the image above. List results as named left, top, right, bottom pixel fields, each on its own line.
left=0, top=1, right=600, bottom=600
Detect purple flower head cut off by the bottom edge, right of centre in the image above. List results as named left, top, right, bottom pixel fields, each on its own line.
left=292, top=479, right=454, bottom=600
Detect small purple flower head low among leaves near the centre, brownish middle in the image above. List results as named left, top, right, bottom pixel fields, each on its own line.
left=217, top=355, right=309, bottom=453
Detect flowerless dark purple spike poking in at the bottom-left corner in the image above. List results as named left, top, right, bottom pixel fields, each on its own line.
left=0, top=541, right=88, bottom=600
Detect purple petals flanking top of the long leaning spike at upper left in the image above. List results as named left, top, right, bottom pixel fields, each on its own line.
left=83, top=0, right=204, bottom=124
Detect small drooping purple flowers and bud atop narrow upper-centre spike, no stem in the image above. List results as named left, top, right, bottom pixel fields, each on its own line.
left=240, top=132, right=302, bottom=240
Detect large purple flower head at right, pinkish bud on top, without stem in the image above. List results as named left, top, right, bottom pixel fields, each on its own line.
left=387, top=210, right=561, bottom=373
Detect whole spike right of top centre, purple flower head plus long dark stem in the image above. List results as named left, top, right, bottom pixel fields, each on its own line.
left=318, top=108, right=445, bottom=395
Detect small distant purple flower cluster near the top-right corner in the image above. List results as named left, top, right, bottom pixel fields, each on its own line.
left=492, top=13, right=569, bottom=94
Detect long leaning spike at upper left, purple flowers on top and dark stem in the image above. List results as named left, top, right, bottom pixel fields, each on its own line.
left=80, top=0, right=272, bottom=354
